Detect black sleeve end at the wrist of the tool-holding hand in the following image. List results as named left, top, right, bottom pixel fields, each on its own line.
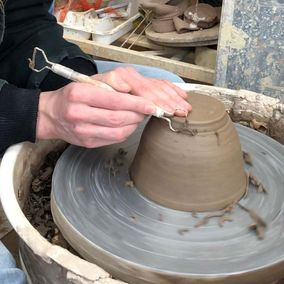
left=0, top=84, right=40, bottom=156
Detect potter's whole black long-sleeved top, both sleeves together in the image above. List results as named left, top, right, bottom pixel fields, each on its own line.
left=0, top=0, right=97, bottom=155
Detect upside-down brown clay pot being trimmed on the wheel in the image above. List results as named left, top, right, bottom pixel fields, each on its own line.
left=130, top=94, right=247, bottom=211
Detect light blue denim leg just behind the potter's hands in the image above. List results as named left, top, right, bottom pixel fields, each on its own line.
left=95, top=60, right=184, bottom=83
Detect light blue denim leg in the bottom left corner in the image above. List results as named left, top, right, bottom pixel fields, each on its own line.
left=0, top=241, right=27, bottom=284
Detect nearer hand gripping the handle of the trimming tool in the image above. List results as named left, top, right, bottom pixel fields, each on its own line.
left=37, top=83, right=155, bottom=148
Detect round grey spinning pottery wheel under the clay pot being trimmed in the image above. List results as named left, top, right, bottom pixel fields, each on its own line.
left=52, top=125, right=284, bottom=283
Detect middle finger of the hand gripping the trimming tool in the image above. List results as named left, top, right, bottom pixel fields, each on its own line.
left=65, top=103, right=144, bottom=127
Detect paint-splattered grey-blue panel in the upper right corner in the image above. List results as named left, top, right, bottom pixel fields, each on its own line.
left=216, top=0, right=284, bottom=101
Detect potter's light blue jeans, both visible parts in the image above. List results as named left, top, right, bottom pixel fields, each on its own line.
left=0, top=60, right=183, bottom=284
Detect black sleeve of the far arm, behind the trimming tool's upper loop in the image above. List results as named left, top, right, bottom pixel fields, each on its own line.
left=0, top=0, right=97, bottom=89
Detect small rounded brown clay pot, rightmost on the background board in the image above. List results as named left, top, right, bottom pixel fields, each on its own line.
left=184, top=3, right=218, bottom=30
